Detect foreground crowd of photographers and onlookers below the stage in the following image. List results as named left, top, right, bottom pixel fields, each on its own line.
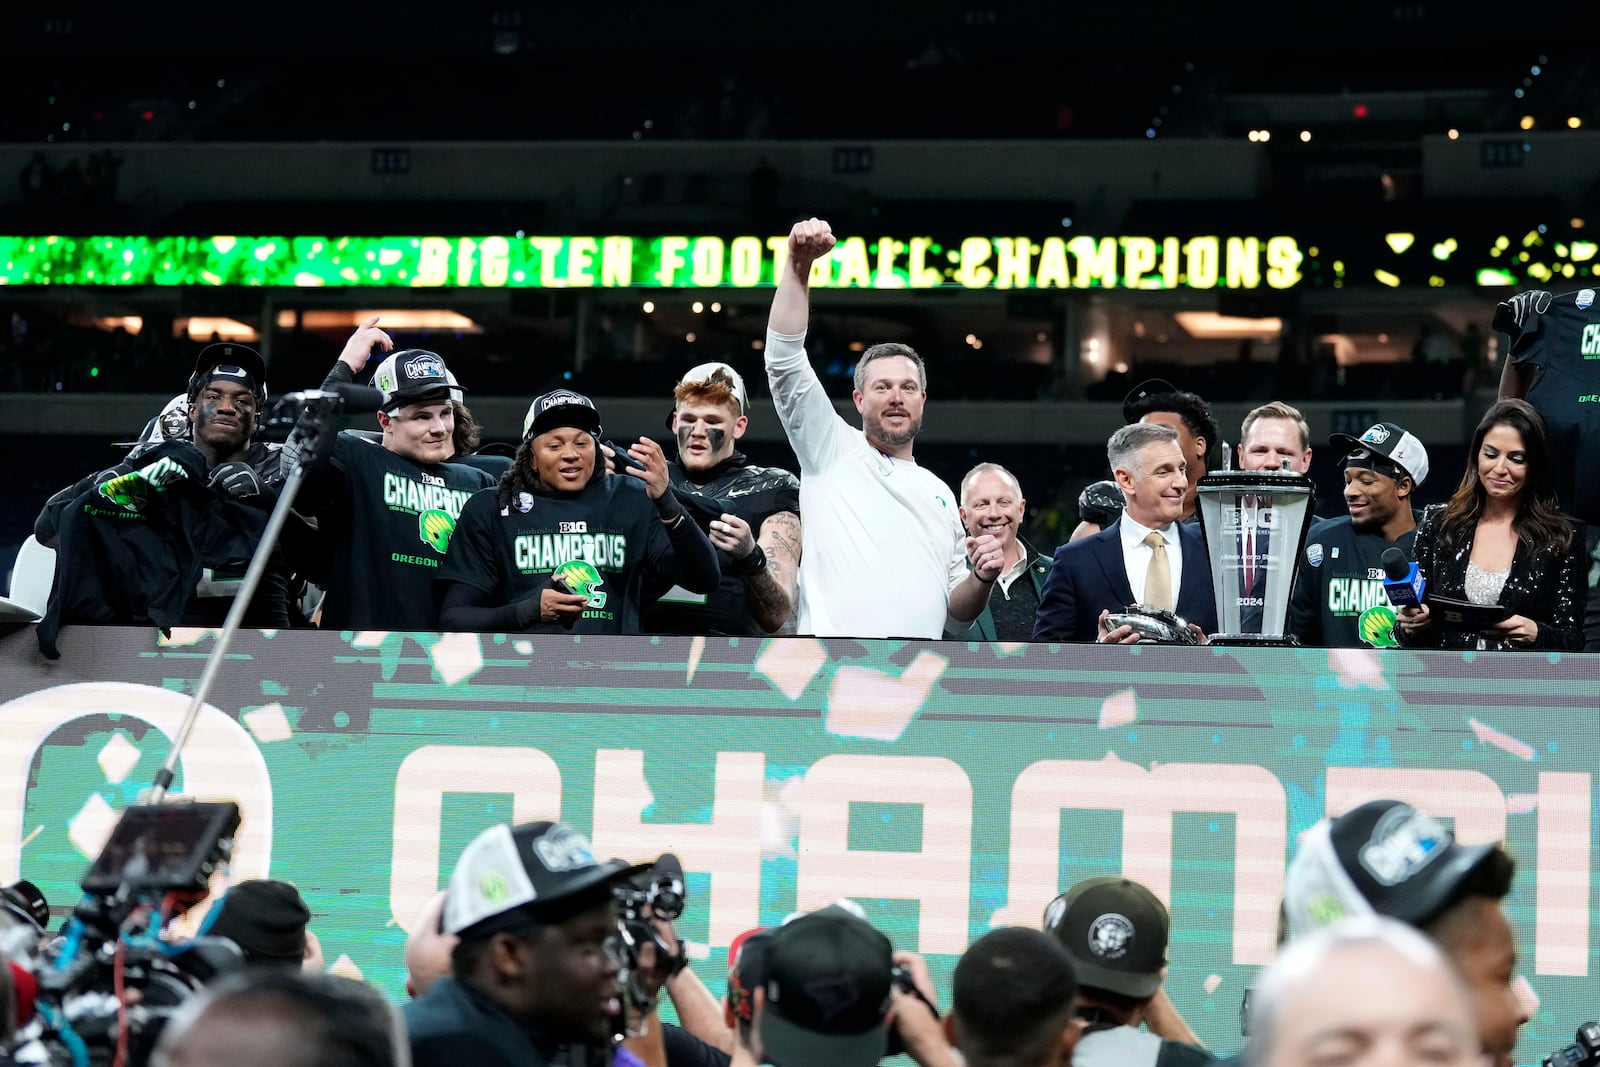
left=0, top=800, right=1528, bottom=1067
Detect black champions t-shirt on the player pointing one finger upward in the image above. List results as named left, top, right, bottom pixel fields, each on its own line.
left=308, top=434, right=493, bottom=630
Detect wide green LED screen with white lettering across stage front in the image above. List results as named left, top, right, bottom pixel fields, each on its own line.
left=0, top=627, right=1600, bottom=1062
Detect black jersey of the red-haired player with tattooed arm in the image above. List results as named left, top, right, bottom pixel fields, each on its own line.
left=643, top=453, right=800, bottom=633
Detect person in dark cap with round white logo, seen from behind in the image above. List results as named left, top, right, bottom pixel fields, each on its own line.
left=1045, top=877, right=1216, bottom=1067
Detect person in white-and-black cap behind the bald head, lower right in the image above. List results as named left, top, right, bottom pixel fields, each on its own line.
left=1283, top=800, right=1528, bottom=1067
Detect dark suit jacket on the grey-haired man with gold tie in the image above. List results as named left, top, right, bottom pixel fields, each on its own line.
left=1034, top=518, right=1216, bottom=641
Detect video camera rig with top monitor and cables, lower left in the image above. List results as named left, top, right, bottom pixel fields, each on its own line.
left=3, top=803, right=243, bottom=1067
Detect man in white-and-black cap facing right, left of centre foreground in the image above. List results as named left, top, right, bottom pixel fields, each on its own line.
left=403, top=822, right=635, bottom=1067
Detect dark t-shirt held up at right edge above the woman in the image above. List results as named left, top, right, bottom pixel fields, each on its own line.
left=1494, top=290, right=1600, bottom=525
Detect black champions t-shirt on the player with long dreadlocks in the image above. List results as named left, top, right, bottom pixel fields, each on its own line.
left=438, top=475, right=686, bottom=633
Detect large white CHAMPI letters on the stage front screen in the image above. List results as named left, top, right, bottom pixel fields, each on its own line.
left=392, top=745, right=1590, bottom=976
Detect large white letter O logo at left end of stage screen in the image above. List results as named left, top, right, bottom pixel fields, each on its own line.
left=0, top=681, right=272, bottom=923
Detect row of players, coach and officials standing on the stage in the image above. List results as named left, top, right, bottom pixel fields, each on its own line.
left=35, top=219, right=1600, bottom=653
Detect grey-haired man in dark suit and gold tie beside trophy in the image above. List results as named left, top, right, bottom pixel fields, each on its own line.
left=1034, top=422, right=1216, bottom=645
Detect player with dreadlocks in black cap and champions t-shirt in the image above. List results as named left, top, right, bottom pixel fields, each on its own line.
left=438, top=389, right=722, bottom=633
